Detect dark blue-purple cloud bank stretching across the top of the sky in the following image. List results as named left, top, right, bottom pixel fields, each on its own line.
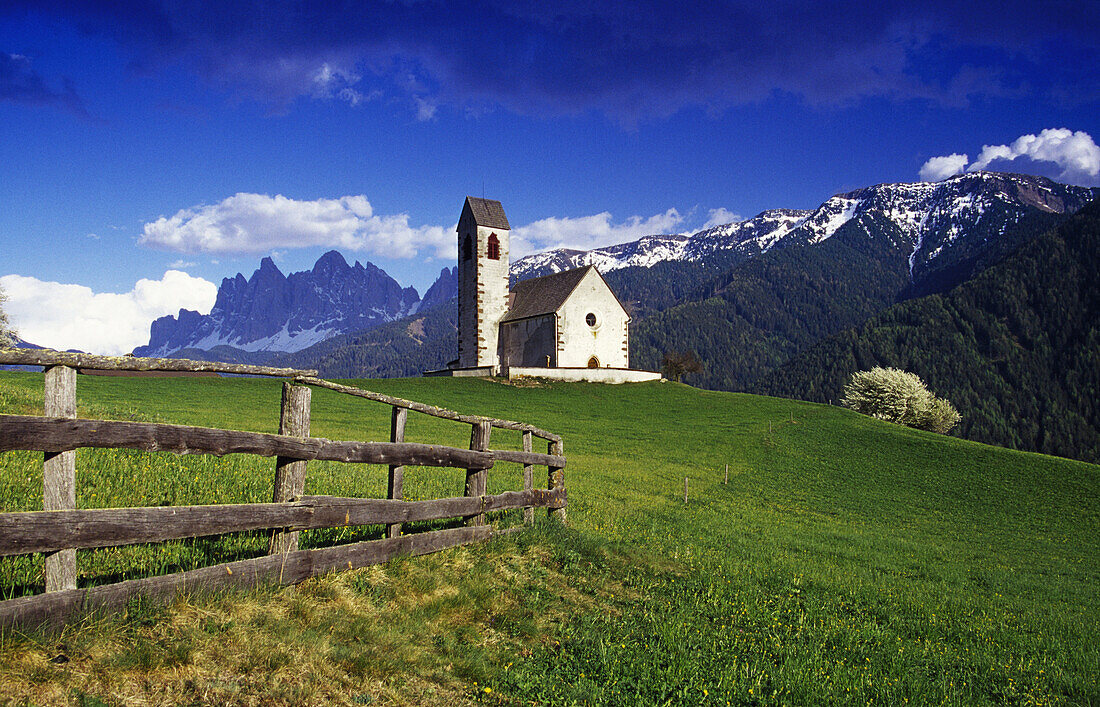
left=10, top=0, right=1100, bottom=122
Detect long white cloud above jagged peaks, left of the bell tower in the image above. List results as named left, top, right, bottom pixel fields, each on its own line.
left=139, top=194, right=457, bottom=258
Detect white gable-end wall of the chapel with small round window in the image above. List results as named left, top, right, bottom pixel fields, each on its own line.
left=557, top=270, right=629, bottom=368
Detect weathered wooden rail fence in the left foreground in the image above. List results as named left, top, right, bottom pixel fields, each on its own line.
left=0, top=350, right=567, bottom=628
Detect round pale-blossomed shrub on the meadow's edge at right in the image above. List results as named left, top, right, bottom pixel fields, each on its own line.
left=840, top=366, right=961, bottom=434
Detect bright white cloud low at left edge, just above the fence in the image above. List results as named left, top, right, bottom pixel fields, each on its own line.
left=0, top=270, right=218, bottom=355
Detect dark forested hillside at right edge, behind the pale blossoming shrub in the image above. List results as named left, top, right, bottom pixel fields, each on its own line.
left=756, top=205, right=1100, bottom=462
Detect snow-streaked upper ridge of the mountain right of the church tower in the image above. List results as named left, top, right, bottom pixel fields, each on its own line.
left=512, top=172, right=1100, bottom=279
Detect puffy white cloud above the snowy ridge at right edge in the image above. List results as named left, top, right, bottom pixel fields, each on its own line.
left=921, top=128, right=1100, bottom=187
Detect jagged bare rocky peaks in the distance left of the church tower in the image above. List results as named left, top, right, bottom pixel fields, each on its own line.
left=134, top=251, right=442, bottom=356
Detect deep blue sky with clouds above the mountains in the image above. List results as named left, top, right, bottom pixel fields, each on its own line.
left=0, top=0, right=1100, bottom=353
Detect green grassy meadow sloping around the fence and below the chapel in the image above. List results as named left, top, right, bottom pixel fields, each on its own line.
left=0, top=373, right=1100, bottom=705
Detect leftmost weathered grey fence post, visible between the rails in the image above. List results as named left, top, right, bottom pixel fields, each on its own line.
left=42, top=366, right=76, bottom=592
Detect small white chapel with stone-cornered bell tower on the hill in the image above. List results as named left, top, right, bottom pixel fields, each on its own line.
left=436, top=197, right=660, bottom=383
